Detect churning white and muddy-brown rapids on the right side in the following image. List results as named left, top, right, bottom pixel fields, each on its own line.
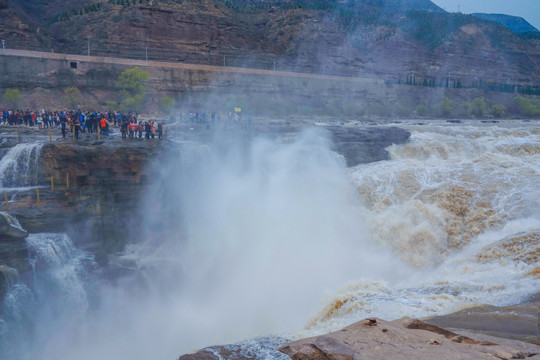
left=308, top=120, right=540, bottom=335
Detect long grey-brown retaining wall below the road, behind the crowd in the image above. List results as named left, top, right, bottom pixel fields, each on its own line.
left=0, top=50, right=387, bottom=113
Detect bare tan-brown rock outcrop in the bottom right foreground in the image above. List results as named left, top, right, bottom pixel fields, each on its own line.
left=280, top=318, right=540, bottom=360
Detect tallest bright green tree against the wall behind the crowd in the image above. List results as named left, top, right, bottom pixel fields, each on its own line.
left=116, top=67, right=148, bottom=112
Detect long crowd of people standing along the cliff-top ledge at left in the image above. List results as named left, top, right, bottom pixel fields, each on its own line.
left=0, top=109, right=164, bottom=139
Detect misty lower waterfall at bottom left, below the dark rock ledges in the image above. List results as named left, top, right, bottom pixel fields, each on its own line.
left=0, top=234, right=97, bottom=359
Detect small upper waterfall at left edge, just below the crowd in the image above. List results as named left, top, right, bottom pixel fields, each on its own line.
left=0, top=143, right=43, bottom=188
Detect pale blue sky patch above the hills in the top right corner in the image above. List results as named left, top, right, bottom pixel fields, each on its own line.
left=431, top=0, right=540, bottom=30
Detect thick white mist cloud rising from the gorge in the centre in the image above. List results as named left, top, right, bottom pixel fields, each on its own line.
left=10, top=131, right=398, bottom=360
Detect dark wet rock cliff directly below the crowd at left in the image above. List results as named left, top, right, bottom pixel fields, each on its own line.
left=0, top=139, right=161, bottom=307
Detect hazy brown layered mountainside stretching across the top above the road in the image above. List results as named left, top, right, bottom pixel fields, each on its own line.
left=0, top=0, right=540, bottom=85
